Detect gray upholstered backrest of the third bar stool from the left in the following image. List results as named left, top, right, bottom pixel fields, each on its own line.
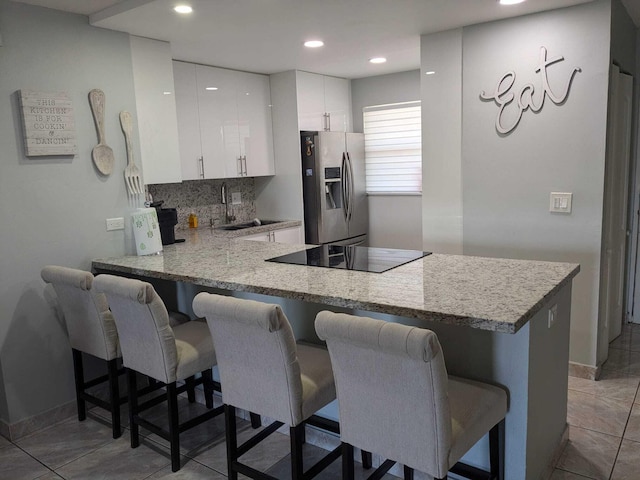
left=193, top=293, right=304, bottom=425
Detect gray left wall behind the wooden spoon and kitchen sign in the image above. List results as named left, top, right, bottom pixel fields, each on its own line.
left=0, top=0, right=140, bottom=427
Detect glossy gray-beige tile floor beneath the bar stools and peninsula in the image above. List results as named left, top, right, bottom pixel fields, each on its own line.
left=0, top=325, right=640, bottom=480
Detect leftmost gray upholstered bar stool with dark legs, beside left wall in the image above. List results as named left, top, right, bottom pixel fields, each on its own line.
left=40, top=265, right=126, bottom=438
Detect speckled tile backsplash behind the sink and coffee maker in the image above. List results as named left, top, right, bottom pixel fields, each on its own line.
left=148, top=177, right=256, bottom=229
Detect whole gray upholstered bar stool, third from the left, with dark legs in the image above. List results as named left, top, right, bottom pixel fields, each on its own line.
left=193, top=293, right=350, bottom=480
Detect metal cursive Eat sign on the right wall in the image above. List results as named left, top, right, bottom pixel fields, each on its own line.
left=480, top=47, right=582, bottom=135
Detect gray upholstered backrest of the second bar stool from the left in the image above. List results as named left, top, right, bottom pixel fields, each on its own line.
left=94, top=275, right=178, bottom=383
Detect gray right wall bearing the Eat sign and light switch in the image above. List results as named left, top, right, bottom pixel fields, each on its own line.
left=462, top=0, right=610, bottom=365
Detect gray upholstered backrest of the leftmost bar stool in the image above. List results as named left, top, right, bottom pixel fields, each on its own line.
left=40, top=265, right=120, bottom=360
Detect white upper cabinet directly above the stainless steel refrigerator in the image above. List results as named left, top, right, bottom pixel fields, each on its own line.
left=296, top=71, right=351, bottom=132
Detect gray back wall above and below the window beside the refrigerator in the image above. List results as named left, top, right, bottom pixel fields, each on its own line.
left=351, top=70, right=422, bottom=250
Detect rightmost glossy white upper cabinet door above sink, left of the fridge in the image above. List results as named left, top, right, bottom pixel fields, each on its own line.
left=235, top=72, right=275, bottom=177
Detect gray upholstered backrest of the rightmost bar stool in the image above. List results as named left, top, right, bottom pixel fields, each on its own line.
left=315, top=311, right=451, bottom=476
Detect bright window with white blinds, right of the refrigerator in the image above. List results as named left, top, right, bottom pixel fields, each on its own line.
left=363, top=102, right=422, bottom=195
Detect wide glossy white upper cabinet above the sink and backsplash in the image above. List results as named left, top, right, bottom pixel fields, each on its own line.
left=174, top=62, right=275, bottom=180
